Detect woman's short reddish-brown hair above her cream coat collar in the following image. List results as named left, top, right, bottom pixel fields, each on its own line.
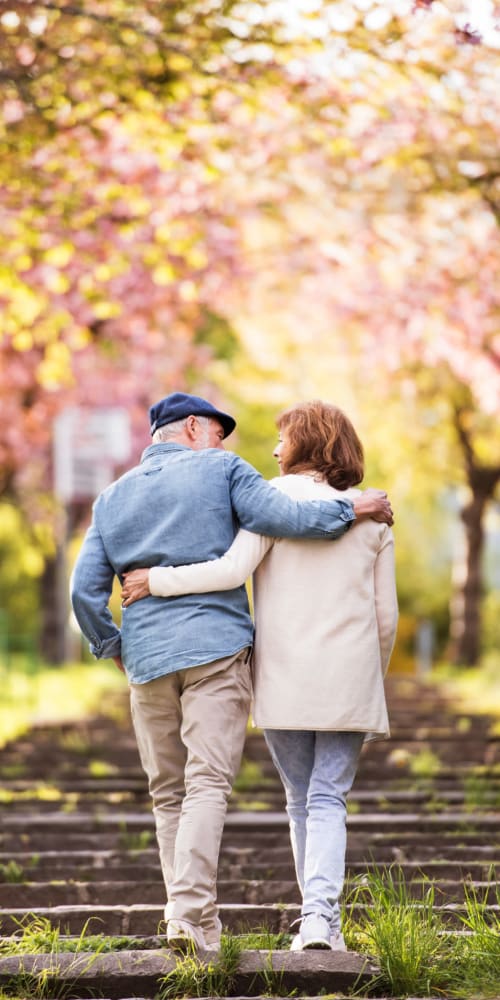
left=276, top=399, right=364, bottom=490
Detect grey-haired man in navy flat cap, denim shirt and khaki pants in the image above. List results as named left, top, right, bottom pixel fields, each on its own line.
left=71, top=392, right=392, bottom=949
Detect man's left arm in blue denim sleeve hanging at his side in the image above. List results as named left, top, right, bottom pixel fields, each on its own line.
left=70, top=521, right=121, bottom=666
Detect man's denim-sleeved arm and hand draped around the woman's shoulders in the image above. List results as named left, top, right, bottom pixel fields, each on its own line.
left=225, top=452, right=393, bottom=539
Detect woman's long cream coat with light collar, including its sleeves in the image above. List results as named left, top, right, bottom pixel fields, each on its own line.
left=149, top=474, right=398, bottom=738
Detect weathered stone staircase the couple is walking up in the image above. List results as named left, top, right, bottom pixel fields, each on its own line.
left=0, top=677, right=500, bottom=1000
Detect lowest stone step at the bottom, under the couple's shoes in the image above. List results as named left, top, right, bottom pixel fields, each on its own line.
left=0, top=950, right=378, bottom=1000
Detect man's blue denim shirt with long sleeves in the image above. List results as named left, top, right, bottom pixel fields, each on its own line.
left=71, top=443, right=355, bottom=684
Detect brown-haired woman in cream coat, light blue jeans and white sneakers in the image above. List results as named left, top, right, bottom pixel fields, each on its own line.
left=123, top=401, right=398, bottom=950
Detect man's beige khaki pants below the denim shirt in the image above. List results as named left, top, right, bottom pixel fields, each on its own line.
left=130, top=649, right=251, bottom=944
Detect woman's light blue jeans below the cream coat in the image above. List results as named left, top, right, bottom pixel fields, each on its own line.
left=264, top=729, right=365, bottom=933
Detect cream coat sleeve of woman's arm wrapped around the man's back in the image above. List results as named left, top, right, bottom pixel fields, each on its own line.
left=149, top=530, right=273, bottom=597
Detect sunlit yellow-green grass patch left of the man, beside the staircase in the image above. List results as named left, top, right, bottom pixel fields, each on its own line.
left=0, top=655, right=126, bottom=747
